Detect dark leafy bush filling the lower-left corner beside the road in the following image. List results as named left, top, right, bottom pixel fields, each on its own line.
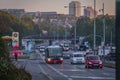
left=0, top=28, right=31, bottom=80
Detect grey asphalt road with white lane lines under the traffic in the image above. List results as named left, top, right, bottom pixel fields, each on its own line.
left=12, top=50, right=115, bottom=80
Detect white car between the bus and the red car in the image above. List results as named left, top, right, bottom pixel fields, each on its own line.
left=70, top=52, right=85, bottom=64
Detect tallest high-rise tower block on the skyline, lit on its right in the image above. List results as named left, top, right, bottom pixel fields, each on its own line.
left=69, top=1, right=81, bottom=17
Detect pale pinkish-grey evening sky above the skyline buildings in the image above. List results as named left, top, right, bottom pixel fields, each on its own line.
left=0, top=0, right=115, bottom=15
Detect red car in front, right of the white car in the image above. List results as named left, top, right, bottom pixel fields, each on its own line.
left=85, top=55, right=103, bottom=68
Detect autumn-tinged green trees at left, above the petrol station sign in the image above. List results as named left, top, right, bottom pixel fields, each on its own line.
left=0, top=11, right=34, bottom=37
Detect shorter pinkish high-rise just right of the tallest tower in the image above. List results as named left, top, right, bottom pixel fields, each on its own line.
left=84, top=7, right=97, bottom=18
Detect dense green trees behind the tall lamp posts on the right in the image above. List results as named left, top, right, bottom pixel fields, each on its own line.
left=75, top=15, right=115, bottom=46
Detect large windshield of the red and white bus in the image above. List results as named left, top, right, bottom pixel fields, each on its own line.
left=48, top=48, right=62, bottom=57
